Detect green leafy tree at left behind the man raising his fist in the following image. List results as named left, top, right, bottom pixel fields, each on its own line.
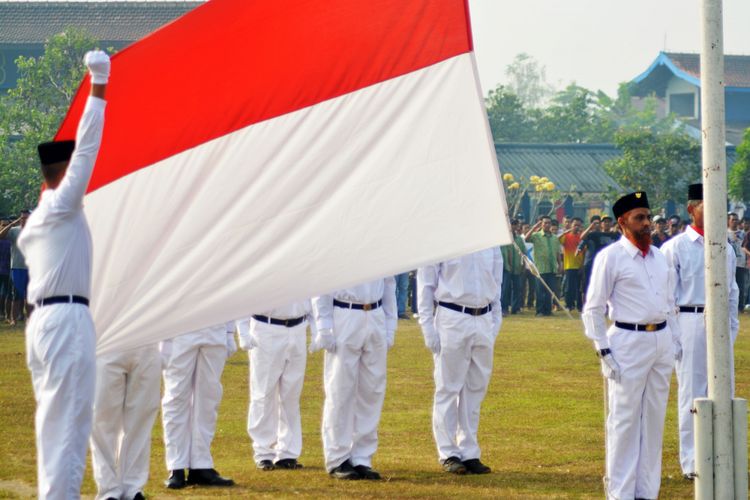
left=0, top=28, right=97, bottom=213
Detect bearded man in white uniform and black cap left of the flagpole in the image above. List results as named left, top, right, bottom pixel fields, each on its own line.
left=582, top=192, right=681, bottom=499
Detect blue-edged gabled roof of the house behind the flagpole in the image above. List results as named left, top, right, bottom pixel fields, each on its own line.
left=632, top=52, right=750, bottom=97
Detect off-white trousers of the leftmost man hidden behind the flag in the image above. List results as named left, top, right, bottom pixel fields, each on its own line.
left=91, top=344, right=161, bottom=500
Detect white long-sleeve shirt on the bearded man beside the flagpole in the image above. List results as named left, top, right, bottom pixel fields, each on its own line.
left=581, top=238, right=679, bottom=349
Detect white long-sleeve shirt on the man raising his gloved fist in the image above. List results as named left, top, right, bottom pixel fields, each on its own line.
left=18, top=97, right=106, bottom=303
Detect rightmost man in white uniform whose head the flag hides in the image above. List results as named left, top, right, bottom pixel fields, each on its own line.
left=417, top=247, right=503, bottom=474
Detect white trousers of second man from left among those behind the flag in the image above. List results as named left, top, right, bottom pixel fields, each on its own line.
left=161, top=325, right=227, bottom=470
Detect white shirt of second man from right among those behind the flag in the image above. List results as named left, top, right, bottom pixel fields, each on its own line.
left=312, top=276, right=398, bottom=335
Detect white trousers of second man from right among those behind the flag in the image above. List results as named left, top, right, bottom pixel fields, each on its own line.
left=322, top=307, right=388, bottom=472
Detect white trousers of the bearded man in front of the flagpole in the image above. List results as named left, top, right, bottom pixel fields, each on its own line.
left=606, top=325, right=674, bottom=500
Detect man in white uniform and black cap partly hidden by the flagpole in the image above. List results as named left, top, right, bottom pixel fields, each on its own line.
left=661, top=184, right=739, bottom=480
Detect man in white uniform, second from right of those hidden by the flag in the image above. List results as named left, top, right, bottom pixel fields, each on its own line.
left=310, top=276, right=398, bottom=480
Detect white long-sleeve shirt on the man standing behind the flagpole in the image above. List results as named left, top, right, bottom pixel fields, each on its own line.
left=661, top=226, right=740, bottom=336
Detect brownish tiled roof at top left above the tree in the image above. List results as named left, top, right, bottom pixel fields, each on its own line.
left=0, top=1, right=204, bottom=44
